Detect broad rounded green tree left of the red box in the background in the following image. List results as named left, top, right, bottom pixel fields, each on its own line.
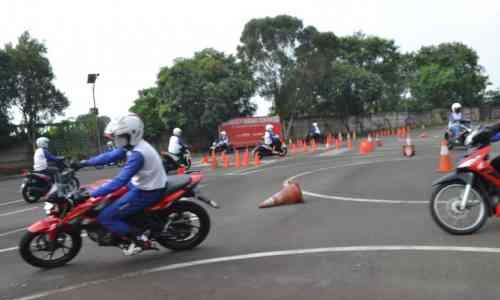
left=131, top=49, right=255, bottom=144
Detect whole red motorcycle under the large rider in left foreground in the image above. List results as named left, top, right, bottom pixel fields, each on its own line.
left=19, top=173, right=218, bottom=268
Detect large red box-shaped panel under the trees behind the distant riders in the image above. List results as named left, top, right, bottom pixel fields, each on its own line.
left=219, top=116, right=283, bottom=148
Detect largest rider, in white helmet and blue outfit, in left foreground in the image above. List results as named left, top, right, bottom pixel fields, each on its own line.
left=73, top=113, right=167, bottom=255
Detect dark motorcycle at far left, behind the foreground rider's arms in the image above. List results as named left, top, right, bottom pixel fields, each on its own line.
left=21, top=159, right=80, bottom=203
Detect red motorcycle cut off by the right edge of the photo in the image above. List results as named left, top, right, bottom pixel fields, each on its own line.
left=430, top=128, right=500, bottom=235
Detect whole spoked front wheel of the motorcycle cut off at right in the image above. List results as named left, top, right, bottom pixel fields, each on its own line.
left=430, top=181, right=489, bottom=235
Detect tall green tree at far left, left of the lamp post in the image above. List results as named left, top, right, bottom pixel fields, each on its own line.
left=5, top=32, right=69, bottom=148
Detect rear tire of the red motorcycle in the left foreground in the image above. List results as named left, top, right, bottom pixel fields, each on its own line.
left=156, top=201, right=210, bottom=251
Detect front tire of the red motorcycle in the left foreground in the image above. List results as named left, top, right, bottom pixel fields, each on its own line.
left=19, top=231, right=82, bottom=269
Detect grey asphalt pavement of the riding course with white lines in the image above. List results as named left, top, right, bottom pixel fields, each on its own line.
left=0, top=132, right=500, bottom=300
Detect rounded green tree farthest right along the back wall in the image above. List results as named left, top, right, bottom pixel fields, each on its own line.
left=410, top=43, right=488, bottom=110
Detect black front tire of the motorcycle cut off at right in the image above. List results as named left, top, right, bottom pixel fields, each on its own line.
left=430, top=181, right=489, bottom=235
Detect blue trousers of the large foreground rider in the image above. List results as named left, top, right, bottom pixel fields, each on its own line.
left=97, top=185, right=164, bottom=236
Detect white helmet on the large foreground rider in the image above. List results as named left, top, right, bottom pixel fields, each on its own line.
left=105, top=113, right=144, bottom=147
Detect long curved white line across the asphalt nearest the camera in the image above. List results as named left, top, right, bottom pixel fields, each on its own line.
left=9, top=245, right=500, bottom=300
